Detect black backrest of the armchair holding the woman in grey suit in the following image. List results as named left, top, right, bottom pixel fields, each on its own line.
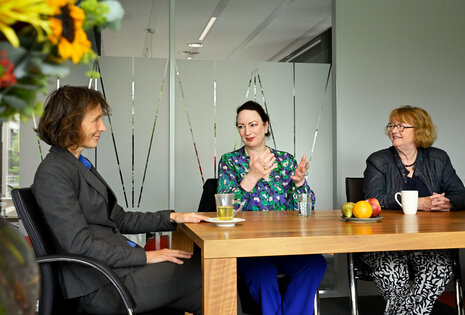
left=11, top=188, right=63, bottom=314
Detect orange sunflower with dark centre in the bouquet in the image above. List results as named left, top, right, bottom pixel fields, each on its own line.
left=48, top=0, right=91, bottom=63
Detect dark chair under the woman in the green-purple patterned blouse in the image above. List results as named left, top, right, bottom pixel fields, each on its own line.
left=198, top=178, right=320, bottom=315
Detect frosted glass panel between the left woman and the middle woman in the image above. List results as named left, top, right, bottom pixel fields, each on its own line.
left=97, top=58, right=168, bottom=211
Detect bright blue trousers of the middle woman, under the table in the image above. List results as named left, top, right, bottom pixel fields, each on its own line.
left=237, top=255, right=326, bottom=315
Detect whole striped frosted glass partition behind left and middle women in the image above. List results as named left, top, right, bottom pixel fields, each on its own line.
left=21, top=57, right=333, bottom=215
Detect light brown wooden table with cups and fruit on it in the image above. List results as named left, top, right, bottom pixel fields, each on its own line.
left=173, top=210, right=465, bottom=315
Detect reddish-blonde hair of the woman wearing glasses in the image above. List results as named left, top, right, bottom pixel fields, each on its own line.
left=389, top=105, right=437, bottom=148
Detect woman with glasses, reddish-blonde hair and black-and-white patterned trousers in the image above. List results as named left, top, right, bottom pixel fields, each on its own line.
left=362, top=105, right=465, bottom=314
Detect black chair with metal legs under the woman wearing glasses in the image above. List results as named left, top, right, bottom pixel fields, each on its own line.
left=345, top=177, right=465, bottom=315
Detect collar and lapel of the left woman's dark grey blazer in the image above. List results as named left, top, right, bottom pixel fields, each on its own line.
left=50, top=147, right=113, bottom=206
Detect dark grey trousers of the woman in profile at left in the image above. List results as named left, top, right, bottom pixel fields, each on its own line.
left=80, top=255, right=202, bottom=315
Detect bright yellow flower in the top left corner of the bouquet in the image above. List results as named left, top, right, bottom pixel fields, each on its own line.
left=0, top=0, right=54, bottom=47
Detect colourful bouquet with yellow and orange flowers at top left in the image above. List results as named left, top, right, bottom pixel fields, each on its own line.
left=0, top=0, right=124, bottom=122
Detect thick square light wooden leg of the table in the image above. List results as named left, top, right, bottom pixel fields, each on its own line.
left=202, top=258, right=237, bottom=315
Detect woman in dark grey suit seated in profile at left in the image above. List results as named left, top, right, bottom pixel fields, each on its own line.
left=32, top=86, right=206, bottom=314
